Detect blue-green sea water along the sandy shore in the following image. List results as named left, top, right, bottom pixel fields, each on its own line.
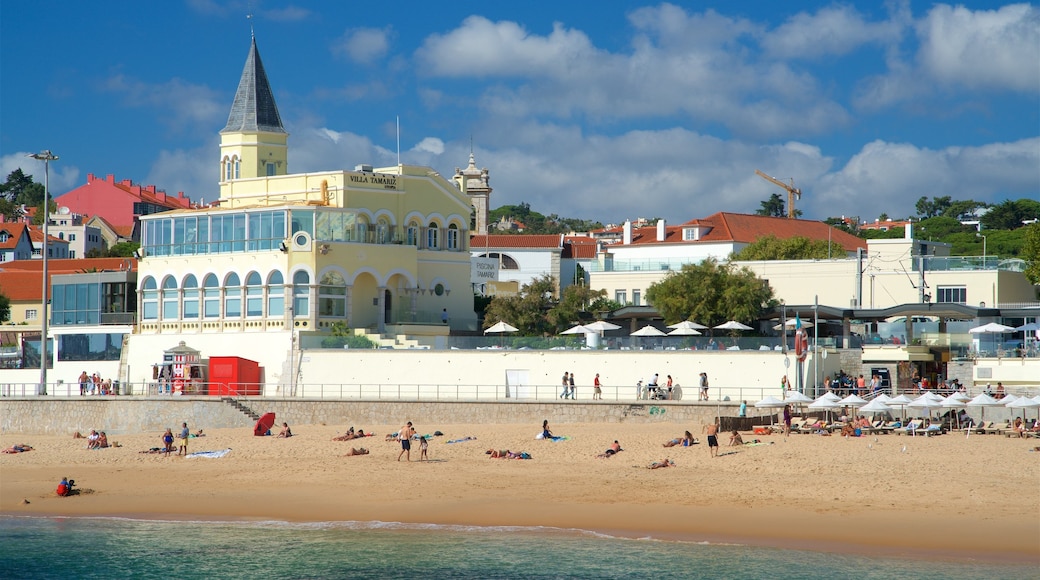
left=0, top=517, right=1037, bottom=580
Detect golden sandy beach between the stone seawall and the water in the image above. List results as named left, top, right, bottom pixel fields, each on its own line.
left=0, top=418, right=1040, bottom=562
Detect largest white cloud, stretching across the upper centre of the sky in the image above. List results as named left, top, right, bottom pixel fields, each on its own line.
left=416, top=10, right=850, bottom=136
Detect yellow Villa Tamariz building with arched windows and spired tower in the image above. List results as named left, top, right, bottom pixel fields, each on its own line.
left=125, top=41, right=476, bottom=390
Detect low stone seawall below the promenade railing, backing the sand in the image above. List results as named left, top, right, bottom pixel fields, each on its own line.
left=0, top=397, right=750, bottom=434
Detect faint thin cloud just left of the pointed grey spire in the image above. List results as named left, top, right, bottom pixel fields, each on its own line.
left=102, top=75, right=230, bottom=133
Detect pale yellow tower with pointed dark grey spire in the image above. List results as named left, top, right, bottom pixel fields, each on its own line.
left=219, top=36, right=289, bottom=191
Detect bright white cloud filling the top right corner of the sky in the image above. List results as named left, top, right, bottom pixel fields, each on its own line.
left=917, top=4, right=1040, bottom=95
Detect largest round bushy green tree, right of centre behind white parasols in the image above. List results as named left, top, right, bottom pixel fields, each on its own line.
left=647, top=258, right=776, bottom=326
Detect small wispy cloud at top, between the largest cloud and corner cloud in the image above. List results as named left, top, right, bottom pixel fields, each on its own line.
left=761, top=5, right=903, bottom=59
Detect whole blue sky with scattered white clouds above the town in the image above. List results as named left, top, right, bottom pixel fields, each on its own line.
left=0, top=0, right=1040, bottom=222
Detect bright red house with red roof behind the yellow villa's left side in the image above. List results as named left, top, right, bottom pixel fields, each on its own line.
left=54, top=174, right=191, bottom=227
